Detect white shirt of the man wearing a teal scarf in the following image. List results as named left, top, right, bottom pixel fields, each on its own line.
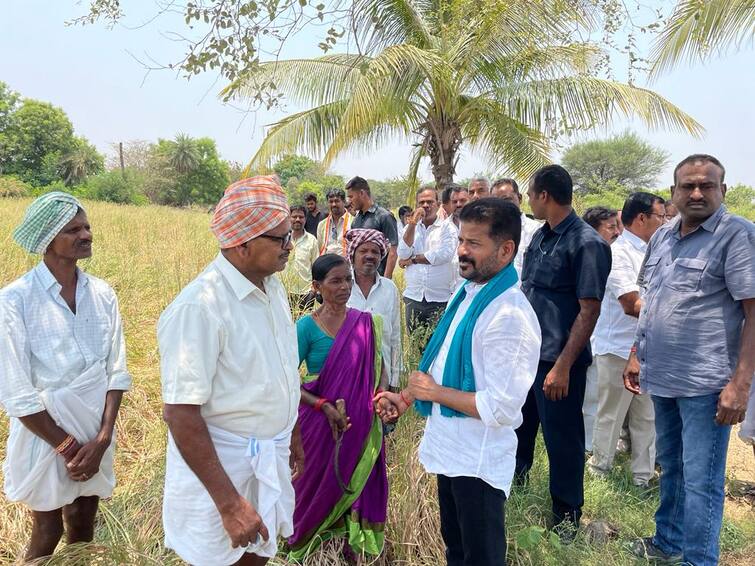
left=419, top=283, right=541, bottom=495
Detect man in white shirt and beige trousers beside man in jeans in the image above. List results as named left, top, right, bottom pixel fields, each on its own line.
left=588, top=192, right=665, bottom=486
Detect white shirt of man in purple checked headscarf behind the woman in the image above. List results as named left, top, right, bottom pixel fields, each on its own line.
left=347, top=275, right=401, bottom=387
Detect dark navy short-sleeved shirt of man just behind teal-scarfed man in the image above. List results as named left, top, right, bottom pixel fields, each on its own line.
left=522, top=210, right=611, bottom=366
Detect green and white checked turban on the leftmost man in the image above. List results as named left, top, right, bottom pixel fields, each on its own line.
left=13, top=191, right=84, bottom=254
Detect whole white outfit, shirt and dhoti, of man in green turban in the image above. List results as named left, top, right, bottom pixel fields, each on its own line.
left=0, top=263, right=131, bottom=511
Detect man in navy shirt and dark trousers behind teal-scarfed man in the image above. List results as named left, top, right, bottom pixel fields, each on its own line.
left=516, top=165, right=611, bottom=542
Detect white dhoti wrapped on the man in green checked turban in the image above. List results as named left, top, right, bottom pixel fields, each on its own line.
left=3, top=362, right=115, bottom=511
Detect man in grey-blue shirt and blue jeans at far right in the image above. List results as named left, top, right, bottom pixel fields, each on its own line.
left=624, top=154, right=755, bottom=566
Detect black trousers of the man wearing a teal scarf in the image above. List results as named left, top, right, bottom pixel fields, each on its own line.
left=438, top=475, right=506, bottom=566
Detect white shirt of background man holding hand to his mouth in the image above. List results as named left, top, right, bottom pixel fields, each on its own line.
left=398, top=215, right=459, bottom=303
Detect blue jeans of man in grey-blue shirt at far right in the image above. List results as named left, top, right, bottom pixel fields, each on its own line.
left=653, top=393, right=731, bottom=566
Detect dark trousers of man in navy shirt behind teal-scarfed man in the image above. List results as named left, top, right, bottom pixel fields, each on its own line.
left=516, top=361, right=587, bottom=525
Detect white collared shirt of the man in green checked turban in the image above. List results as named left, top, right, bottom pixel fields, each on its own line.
left=0, top=262, right=131, bottom=417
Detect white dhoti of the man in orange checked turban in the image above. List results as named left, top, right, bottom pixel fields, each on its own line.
left=163, top=426, right=294, bottom=566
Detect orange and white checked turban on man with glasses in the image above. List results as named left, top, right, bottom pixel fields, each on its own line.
left=210, top=175, right=289, bottom=249
